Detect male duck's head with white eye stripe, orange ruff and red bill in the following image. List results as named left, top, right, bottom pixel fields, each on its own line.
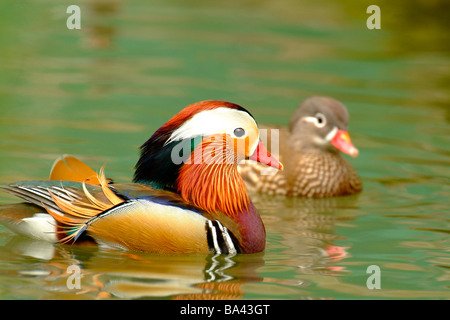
left=134, top=100, right=282, bottom=214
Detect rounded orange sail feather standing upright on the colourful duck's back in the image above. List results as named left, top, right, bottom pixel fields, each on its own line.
left=49, top=155, right=100, bottom=185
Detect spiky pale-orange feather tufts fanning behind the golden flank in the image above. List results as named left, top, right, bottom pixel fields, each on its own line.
left=44, top=165, right=124, bottom=242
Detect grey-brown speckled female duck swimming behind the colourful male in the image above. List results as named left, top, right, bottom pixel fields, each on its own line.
left=239, top=97, right=362, bottom=198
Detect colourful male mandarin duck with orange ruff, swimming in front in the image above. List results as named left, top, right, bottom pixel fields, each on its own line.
left=0, top=100, right=282, bottom=254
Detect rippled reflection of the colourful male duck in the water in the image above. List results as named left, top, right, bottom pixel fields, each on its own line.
left=1, top=235, right=264, bottom=299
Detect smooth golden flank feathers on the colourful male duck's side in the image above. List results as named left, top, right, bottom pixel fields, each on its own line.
left=87, top=199, right=209, bottom=253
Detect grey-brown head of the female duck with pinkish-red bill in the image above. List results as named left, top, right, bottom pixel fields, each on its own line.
left=289, top=97, right=358, bottom=157
